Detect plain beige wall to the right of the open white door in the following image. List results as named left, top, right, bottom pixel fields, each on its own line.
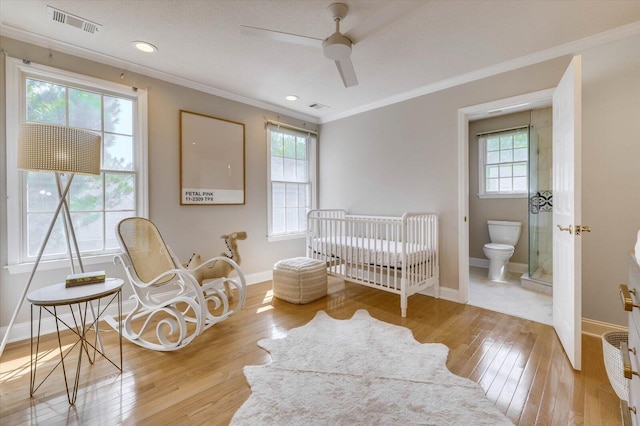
left=582, top=37, right=640, bottom=325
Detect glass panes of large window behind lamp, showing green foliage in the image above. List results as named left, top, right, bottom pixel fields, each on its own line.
left=26, top=79, right=136, bottom=256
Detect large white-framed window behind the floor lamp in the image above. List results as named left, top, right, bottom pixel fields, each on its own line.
left=7, top=58, right=147, bottom=271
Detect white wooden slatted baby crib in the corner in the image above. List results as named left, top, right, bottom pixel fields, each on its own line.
left=307, top=210, right=440, bottom=317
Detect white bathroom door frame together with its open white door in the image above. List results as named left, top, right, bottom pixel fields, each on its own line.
left=458, top=55, right=582, bottom=370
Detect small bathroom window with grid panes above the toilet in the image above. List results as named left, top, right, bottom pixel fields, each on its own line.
left=478, top=127, right=529, bottom=198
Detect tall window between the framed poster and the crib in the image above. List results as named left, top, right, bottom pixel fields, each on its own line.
left=267, top=124, right=316, bottom=240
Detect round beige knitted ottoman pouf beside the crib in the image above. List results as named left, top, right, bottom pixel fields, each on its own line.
left=273, top=257, right=327, bottom=304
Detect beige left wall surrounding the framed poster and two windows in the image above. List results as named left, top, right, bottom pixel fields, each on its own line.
left=0, top=38, right=318, bottom=335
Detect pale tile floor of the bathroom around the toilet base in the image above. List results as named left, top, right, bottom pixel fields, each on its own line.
left=469, top=266, right=553, bottom=325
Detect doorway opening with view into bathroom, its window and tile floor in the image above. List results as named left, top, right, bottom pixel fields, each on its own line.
left=468, top=105, right=553, bottom=325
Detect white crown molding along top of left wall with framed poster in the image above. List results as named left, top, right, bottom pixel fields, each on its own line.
left=0, top=25, right=320, bottom=124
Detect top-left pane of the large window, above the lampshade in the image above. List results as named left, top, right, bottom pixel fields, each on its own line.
left=27, top=79, right=67, bottom=126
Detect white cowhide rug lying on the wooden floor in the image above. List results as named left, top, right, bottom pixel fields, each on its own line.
left=231, top=310, right=512, bottom=426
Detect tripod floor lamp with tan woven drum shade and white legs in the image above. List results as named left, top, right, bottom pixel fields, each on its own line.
left=0, top=123, right=101, bottom=356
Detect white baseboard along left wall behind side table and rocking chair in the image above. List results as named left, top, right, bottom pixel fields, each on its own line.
left=0, top=270, right=273, bottom=343
